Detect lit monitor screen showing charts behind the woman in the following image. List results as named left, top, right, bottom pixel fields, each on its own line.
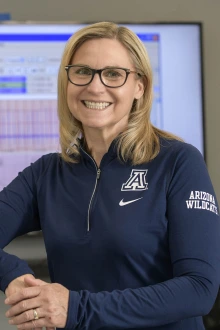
left=0, top=23, right=204, bottom=190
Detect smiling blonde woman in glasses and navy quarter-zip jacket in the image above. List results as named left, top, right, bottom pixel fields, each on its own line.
left=0, top=22, right=220, bottom=330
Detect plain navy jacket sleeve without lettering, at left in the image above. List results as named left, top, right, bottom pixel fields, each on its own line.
left=0, top=163, right=40, bottom=291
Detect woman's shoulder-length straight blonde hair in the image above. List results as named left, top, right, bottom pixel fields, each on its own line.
left=58, top=22, right=179, bottom=165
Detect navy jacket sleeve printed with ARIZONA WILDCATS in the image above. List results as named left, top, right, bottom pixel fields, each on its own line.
left=66, top=145, right=220, bottom=329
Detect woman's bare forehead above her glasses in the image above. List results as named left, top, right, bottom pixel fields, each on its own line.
left=71, top=38, right=134, bottom=69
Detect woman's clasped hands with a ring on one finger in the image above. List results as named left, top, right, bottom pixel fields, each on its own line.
left=5, top=276, right=69, bottom=330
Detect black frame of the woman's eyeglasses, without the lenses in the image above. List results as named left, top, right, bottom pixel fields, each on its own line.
left=65, top=64, right=142, bottom=88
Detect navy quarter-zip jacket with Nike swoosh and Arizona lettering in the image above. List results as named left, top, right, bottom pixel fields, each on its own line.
left=0, top=140, right=220, bottom=330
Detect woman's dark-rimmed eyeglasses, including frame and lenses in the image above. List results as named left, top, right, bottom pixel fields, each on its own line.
left=65, top=65, right=141, bottom=88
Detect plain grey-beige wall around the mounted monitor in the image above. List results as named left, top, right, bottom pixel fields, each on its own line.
left=0, top=0, right=220, bottom=202
